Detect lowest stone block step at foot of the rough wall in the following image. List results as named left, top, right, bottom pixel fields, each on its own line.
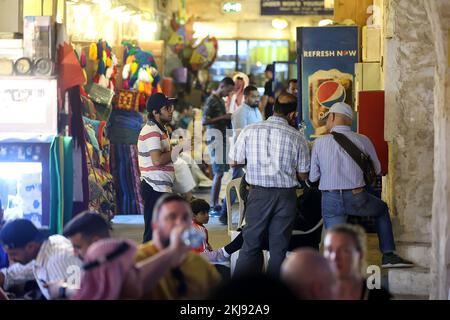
left=388, top=267, right=431, bottom=297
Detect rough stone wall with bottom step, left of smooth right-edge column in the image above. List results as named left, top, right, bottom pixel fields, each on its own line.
left=383, top=0, right=436, bottom=297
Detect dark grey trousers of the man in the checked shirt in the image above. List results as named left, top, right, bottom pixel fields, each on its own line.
left=234, top=187, right=297, bottom=277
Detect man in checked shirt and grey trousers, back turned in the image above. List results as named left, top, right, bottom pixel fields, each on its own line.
left=230, top=94, right=310, bottom=277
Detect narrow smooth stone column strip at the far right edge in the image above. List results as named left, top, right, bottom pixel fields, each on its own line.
left=425, top=0, right=450, bottom=299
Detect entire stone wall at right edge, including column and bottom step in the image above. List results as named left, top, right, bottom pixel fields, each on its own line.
left=384, top=0, right=450, bottom=299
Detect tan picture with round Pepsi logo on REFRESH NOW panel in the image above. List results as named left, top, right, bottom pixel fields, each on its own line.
left=308, top=69, right=353, bottom=135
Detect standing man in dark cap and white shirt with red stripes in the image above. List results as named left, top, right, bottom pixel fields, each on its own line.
left=137, top=93, right=176, bottom=242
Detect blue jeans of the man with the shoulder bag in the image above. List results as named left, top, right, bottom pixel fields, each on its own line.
left=322, top=191, right=395, bottom=253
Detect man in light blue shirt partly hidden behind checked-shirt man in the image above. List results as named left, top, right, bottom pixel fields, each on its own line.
left=219, top=86, right=263, bottom=224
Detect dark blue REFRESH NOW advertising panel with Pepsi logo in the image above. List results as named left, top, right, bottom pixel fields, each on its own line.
left=297, top=26, right=359, bottom=139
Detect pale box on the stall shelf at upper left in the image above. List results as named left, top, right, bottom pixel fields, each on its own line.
left=23, top=16, right=56, bottom=61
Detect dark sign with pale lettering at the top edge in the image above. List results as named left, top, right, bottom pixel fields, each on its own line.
left=261, top=0, right=333, bottom=16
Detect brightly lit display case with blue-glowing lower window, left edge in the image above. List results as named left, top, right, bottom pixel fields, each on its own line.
left=0, top=76, right=57, bottom=229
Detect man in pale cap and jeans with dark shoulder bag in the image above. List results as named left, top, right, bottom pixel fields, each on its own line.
left=309, top=102, right=412, bottom=268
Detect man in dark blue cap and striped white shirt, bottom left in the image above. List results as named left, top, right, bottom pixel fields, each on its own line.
left=0, top=219, right=82, bottom=299
